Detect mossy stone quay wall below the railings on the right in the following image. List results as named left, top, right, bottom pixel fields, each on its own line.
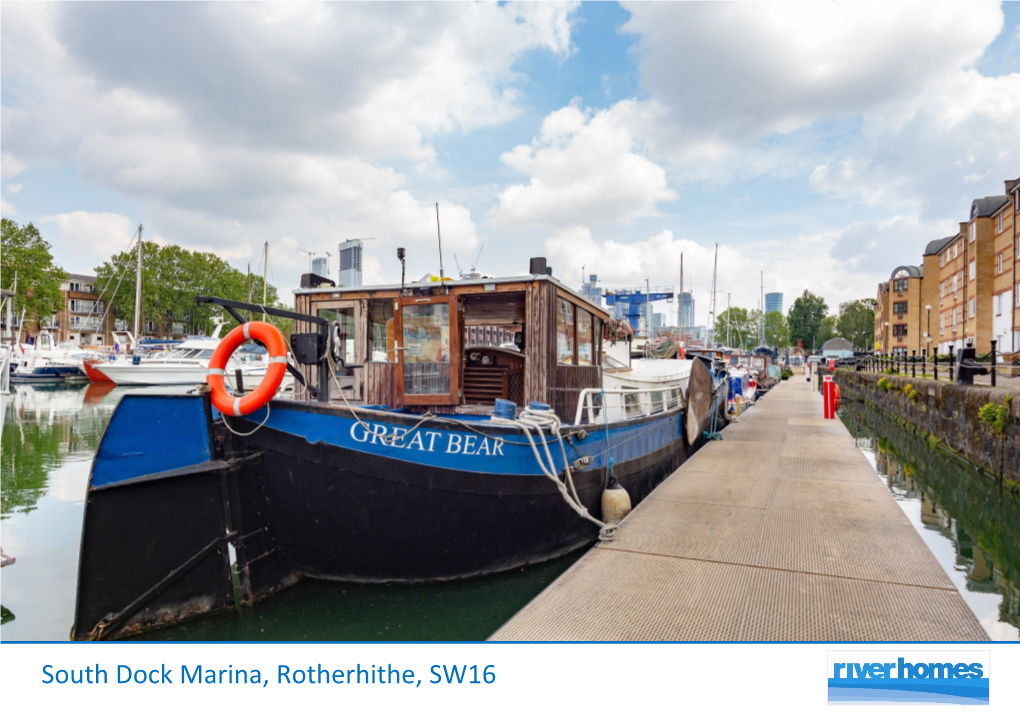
left=834, top=370, right=1020, bottom=488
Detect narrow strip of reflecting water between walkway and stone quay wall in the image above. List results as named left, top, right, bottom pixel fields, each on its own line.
left=839, top=402, right=1020, bottom=640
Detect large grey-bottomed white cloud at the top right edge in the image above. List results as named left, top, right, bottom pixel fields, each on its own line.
left=624, top=1, right=1003, bottom=149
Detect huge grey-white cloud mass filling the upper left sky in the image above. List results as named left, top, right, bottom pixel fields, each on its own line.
left=0, top=3, right=576, bottom=288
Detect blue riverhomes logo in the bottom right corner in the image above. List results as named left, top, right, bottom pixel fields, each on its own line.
left=828, top=651, right=989, bottom=705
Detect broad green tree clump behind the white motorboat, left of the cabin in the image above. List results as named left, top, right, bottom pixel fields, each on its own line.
left=96, top=242, right=283, bottom=333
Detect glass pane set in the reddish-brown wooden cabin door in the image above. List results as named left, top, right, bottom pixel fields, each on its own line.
left=401, top=303, right=451, bottom=397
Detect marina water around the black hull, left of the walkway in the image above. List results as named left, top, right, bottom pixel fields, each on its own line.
left=0, top=385, right=580, bottom=640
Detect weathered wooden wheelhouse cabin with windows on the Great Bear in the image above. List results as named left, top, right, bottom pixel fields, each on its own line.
left=295, top=259, right=610, bottom=419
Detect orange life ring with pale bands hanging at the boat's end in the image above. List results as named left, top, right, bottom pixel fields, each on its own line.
left=205, top=320, right=287, bottom=416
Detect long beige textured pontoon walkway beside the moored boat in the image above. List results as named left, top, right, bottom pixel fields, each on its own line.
left=491, top=376, right=987, bottom=641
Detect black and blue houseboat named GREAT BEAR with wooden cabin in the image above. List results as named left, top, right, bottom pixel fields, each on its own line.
left=72, top=258, right=726, bottom=639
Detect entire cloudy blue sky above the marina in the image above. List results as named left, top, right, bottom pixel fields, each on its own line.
left=0, top=0, right=1020, bottom=324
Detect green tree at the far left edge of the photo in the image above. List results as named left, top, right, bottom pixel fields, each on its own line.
left=0, top=217, right=67, bottom=319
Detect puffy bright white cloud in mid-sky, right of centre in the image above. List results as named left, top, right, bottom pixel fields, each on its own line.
left=494, top=103, right=676, bottom=226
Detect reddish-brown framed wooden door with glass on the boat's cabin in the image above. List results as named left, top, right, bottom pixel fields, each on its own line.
left=394, top=296, right=461, bottom=406
